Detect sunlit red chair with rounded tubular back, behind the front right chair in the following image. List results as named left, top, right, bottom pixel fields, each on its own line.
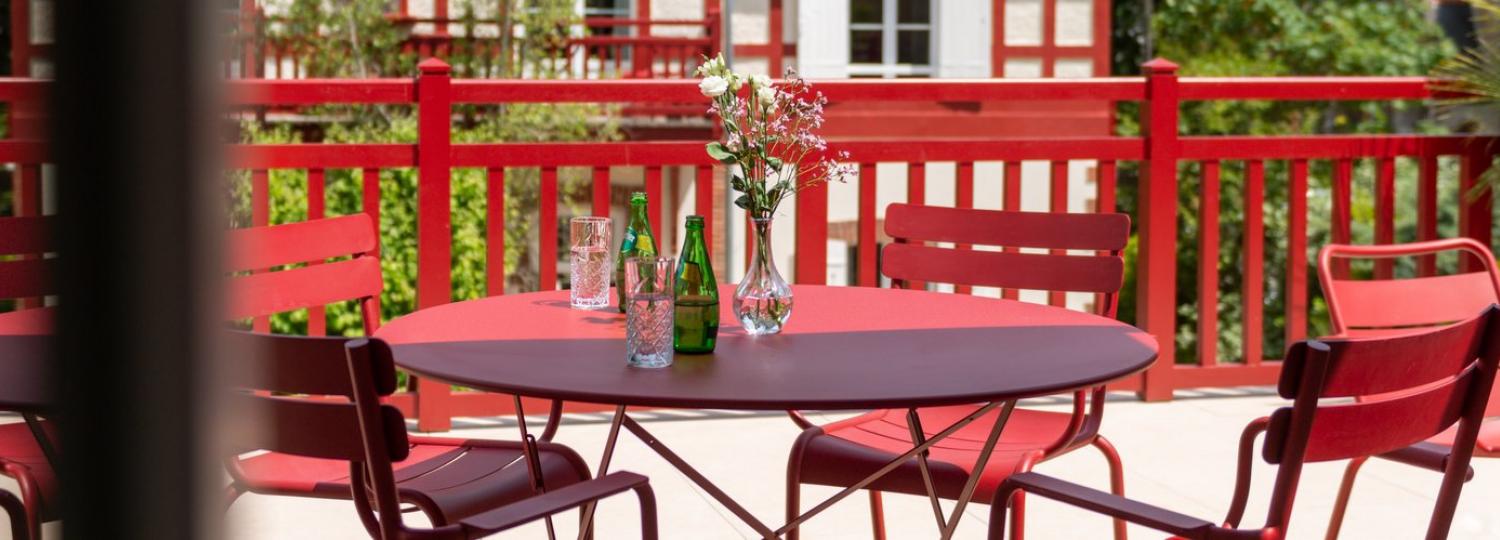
left=1319, top=239, right=1500, bottom=540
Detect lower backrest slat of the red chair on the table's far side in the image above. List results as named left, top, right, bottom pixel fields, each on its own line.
left=881, top=245, right=1125, bottom=293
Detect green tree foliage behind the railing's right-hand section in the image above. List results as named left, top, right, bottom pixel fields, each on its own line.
left=1113, top=0, right=1457, bottom=362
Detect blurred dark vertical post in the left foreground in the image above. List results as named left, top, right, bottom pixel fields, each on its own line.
left=50, top=0, right=222, bottom=540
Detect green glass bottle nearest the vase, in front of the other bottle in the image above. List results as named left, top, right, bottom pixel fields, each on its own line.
left=672, top=216, right=719, bottom=353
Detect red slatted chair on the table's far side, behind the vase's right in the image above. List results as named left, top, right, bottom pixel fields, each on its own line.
left=786, top=204, right=1130, bottom=539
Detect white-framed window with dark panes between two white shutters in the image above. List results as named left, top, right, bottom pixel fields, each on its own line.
left=849, top=0, right=933, bottom=78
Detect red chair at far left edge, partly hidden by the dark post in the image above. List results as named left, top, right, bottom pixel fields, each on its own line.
left=0, top=218, right=62, bottom=539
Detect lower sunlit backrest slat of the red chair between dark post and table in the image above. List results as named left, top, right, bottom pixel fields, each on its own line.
left=228, top=257, right=384, bottom=320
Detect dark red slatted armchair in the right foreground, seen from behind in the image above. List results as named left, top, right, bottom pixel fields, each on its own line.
left=990, top=306, right=1500, bottom=540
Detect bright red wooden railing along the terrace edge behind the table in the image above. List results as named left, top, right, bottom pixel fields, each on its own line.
left=217, top=62, right=1493, bottom=429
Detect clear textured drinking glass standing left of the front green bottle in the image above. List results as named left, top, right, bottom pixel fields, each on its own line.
left=626, top=257, right=674, bottom=368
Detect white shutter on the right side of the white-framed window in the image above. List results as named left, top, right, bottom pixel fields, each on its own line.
left=933, top=0, right=995, bottom=78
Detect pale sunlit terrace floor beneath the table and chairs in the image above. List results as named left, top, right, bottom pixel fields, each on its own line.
left=228, top=389, right=1500, bottom=540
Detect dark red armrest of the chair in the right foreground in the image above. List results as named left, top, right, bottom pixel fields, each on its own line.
left=996, top=473, right=1215, bottom=537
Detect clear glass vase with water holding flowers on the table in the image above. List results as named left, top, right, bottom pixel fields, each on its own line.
left=735, top=219, right=792, bottom=336
